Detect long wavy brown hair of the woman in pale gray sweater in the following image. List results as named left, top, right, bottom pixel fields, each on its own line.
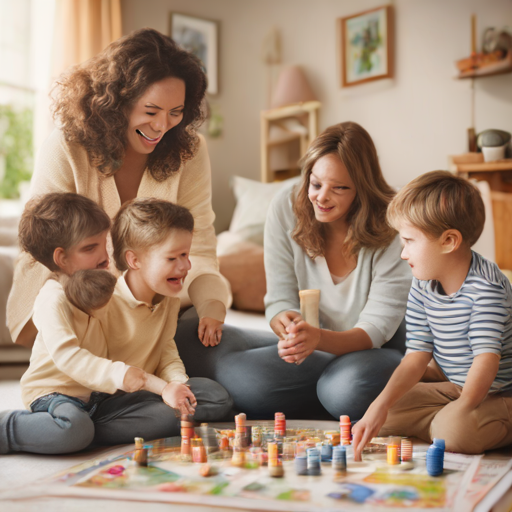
left=292, top=122, right=396, bottom=259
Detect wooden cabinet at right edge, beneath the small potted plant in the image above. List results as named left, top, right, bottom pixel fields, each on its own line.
left=449, top=153, right=512, bottom=270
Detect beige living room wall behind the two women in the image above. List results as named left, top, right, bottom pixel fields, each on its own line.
left=122, top=0, right=512, bottom=231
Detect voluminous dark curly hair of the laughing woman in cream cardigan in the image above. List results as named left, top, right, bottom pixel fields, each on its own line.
left=53, top=28, right=207, bottom=181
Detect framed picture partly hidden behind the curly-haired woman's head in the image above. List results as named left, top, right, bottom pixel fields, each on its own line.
left=169, top=12, right=219, bottom=94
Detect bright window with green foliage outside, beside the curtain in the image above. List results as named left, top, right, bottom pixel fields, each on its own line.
left=0, top=0, right=55, bottom=208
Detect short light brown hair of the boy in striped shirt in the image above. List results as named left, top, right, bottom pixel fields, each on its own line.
left=386, top=171, right=485, bottom=247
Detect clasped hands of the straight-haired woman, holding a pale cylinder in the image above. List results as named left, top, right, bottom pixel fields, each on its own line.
left=277, top=320, right=321, bottom=364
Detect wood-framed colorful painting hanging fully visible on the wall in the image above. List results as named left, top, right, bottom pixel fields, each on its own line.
left=338, top=5, right=394, bottom=87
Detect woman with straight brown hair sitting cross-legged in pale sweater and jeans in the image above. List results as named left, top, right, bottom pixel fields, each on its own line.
left=197, top=123, right=412, bottom=420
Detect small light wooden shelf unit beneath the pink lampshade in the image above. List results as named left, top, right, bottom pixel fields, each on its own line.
left=260, top=101, right=320, bottom=183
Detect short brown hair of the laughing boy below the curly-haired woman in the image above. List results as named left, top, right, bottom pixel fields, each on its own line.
left=112, top=198, right=194, bottom=271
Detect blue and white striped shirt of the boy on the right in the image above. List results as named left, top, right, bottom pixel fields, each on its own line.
left=406, top=252, right=512, bottom=392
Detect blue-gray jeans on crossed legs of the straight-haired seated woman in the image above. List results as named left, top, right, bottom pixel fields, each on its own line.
left=175, top=308, right=405, bottom=420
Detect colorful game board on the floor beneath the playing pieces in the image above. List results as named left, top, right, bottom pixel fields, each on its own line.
left=3, top=422, right=504, bottom=512
